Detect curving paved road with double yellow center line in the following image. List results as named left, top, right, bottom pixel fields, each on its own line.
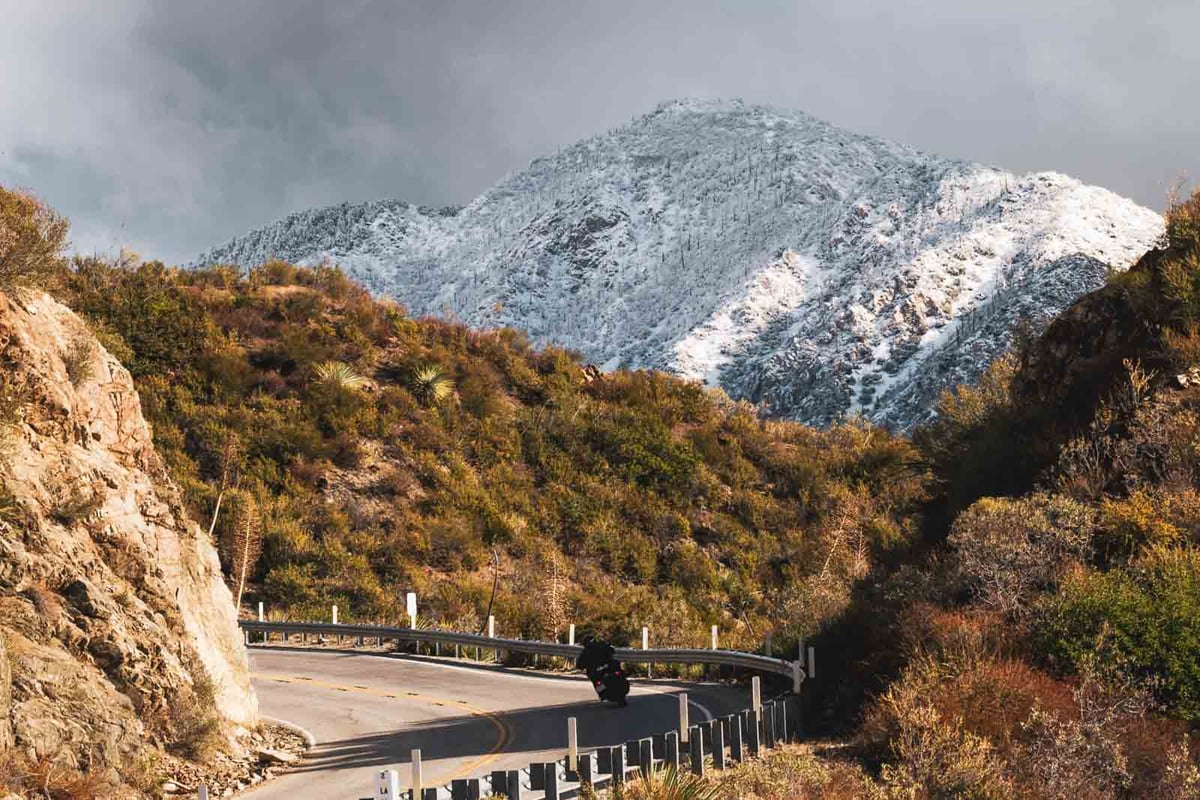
left=244, top=648, right=750, bottom=800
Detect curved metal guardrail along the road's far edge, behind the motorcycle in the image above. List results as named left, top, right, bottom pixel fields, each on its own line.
left=239, top=620, right=804, bottom=692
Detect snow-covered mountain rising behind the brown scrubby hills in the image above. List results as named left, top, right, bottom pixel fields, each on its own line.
left=198, top=101, right=1163, bottom=428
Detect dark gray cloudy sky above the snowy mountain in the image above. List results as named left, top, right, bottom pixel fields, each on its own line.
left=0, top=0, right=1200, bottom=261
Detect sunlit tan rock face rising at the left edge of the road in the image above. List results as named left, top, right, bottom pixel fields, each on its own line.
left=0, top=294, right=258, bottom=772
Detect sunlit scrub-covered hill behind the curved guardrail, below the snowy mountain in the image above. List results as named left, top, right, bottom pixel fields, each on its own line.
left=64, top=260, right=923, bottom=648
